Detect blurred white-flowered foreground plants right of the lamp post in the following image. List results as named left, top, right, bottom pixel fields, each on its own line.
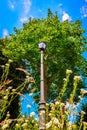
left=46, top=70, right=87, bottom=130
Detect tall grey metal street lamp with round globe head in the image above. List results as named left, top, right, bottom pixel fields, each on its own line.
left=39, top=42, right=46, bottom=130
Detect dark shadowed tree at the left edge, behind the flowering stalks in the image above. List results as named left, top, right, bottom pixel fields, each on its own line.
left=0, top=39, right=26, bottom=124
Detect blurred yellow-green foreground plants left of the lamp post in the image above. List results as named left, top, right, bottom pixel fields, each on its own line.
left=0, top=60, right=37, bottom=130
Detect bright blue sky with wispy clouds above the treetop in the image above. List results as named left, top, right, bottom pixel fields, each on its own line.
left=0, top=0, right=87, bottom=38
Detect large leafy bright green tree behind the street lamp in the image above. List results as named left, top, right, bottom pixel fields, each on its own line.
left=3, top=10, right=87, bottom=101
